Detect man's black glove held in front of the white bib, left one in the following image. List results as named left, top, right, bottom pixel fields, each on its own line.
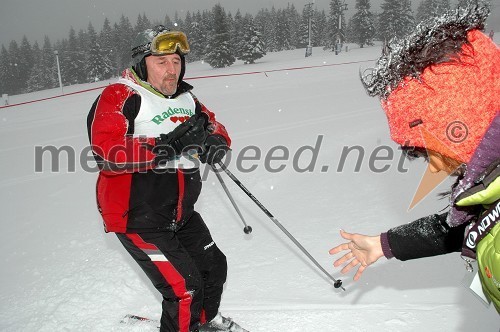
left=152, top=114, right=207, bottom=164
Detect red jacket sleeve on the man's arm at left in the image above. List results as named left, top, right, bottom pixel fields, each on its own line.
left=89, top=84, right=155, bottom=173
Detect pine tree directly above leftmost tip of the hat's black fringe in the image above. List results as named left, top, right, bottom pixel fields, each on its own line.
left=350, top=0, right=375, bottom=48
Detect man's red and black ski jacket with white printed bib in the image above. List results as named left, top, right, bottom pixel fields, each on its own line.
left=87, top=69, right=231, bottom=233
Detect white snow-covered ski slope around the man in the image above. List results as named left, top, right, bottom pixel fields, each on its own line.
left=0, top=42, right=500, bottom=332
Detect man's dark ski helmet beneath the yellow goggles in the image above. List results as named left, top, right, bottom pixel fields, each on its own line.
left=132, top=25, right=186, bottom=84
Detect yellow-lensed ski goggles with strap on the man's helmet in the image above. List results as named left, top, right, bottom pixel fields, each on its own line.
left=132, top=31, right=190, bottom=57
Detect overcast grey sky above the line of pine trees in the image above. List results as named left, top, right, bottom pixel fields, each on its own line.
left=0, top=0, right=500, bottom=47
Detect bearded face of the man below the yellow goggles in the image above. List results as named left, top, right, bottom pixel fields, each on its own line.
left=146, top=53, right=181, bottom=96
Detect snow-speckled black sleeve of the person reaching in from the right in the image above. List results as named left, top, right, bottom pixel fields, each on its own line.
left=387, top=213, right=466, bottom=261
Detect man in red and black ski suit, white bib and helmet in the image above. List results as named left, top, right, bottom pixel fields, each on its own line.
left=87, top=25, right=246, bottom=332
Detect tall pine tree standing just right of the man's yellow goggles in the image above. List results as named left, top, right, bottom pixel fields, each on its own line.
left=205, top=4, right=235, bottom=68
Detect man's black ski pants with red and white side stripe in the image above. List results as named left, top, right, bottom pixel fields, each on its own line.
left=117, top=212, right=227, bottom=332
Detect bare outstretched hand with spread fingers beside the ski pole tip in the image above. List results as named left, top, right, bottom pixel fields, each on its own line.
left=329, top=230, right=384, bottom=281
